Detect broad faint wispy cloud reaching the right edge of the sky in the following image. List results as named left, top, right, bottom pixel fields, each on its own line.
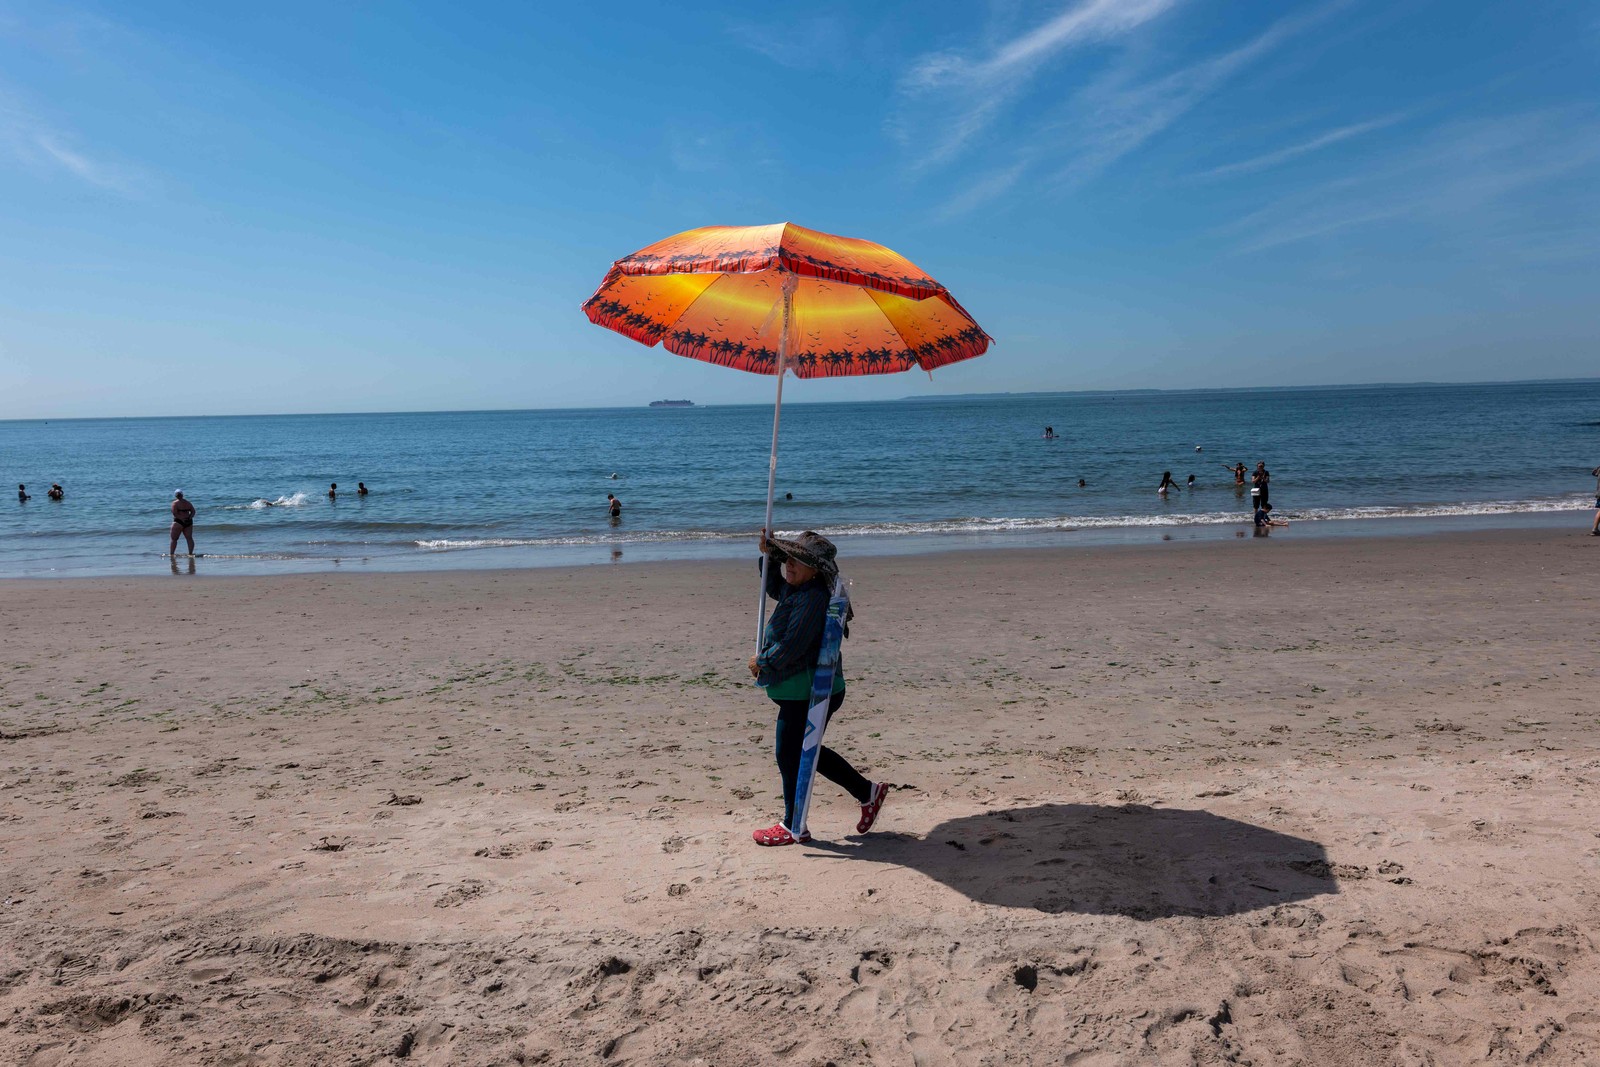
left=1218, top=109, right=1600, bottom=258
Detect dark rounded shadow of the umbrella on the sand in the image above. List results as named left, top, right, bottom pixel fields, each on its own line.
left=810, top=805, right=1339, bottom=918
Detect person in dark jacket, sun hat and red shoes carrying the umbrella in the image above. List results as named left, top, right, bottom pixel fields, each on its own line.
left=749, top=530, right=890, bottom=845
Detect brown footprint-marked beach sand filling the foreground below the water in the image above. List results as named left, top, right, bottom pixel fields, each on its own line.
left=0, top=530, right=1600, bottom=1067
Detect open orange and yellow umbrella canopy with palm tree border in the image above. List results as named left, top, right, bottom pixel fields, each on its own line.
left=584, top=222, right=990, bottom=378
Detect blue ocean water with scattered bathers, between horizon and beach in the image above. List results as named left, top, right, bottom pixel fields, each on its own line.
left=0, top=381, right=1600, bottom=577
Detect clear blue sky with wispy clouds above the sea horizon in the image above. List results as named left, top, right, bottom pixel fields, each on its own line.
left=0, top=0, right=1600, bottom=418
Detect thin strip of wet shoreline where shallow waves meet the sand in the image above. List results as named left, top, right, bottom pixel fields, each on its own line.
left=0, top=507, right=1592, bottom=589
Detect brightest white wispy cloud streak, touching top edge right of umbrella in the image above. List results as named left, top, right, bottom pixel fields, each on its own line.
left=891, top=0, right=1181, bottom=170
